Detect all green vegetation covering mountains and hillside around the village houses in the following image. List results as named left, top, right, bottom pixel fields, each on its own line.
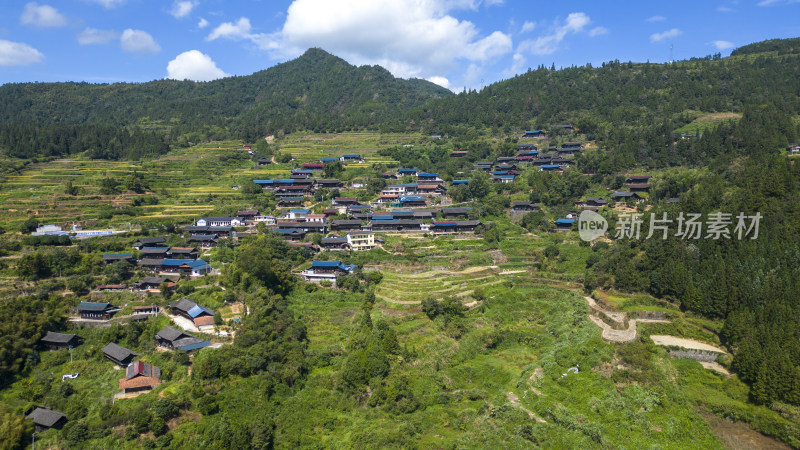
left=0, top=41, right=800, bottom=449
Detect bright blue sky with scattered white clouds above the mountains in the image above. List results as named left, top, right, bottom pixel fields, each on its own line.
left=0, top=0, right=800, bottom=91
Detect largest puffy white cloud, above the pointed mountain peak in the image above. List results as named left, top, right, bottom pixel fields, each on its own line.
left=234, top=0, right=512, bottom=78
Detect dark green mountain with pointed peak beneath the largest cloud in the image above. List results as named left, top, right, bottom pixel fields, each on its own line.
left=0, top=49, right=452, bottom=145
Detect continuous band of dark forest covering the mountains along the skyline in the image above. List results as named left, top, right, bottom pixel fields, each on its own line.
left=0, top=39, right=800, bottom=164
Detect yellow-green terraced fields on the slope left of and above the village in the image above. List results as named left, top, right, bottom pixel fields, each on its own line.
left=0, top=132, right=427, bottom=227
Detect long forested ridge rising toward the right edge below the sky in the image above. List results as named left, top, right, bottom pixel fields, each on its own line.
left=410, top=40, right=800, bottom=136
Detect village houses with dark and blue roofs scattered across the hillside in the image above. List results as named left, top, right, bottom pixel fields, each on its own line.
left=27, top=130, right=664, bottom=431
